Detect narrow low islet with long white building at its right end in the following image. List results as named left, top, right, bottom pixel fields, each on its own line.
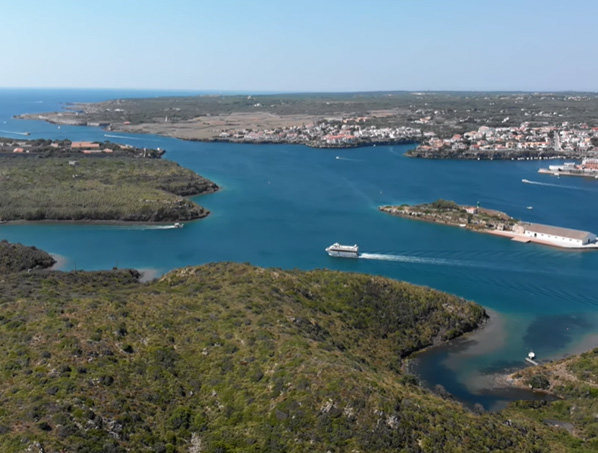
left=378, top=199, right=598, bottom=249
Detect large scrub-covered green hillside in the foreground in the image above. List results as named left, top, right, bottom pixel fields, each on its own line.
left=0, top=264, right=569, bottom=452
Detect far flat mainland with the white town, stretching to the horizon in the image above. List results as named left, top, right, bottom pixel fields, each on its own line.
left=18, top=92, right=598, bottom=160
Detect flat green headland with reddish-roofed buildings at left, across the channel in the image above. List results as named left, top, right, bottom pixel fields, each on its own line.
left=0, top=138, right=218, bottom=222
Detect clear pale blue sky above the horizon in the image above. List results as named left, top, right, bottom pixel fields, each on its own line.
left=0, top=0, right=598, bottom=91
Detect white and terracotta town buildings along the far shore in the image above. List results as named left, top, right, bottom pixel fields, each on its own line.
left=218, top=117, right=598, bottom=159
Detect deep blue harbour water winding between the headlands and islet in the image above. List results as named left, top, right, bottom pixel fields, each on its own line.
left=0, top=90, right=598, bottom=407
